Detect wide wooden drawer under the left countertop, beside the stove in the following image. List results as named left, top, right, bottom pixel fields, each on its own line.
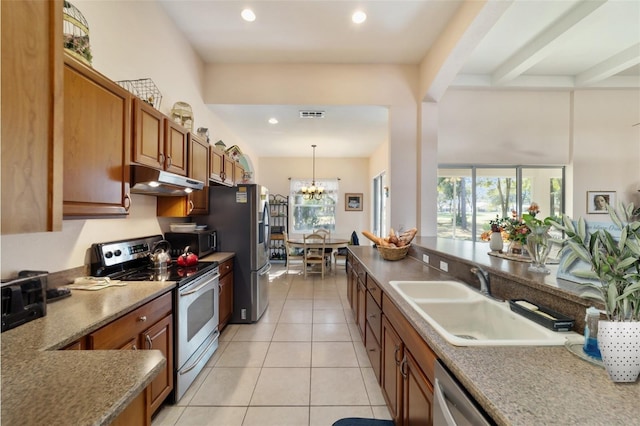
left=89, top=292, right=172, bottom=349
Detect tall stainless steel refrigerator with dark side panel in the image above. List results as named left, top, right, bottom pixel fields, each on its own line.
left=206, top=184, right=271, bottom=323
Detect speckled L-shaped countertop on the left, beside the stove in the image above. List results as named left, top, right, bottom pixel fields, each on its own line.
left=1, top=282, right=175, bottom=425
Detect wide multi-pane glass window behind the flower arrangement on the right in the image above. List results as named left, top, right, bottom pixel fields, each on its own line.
left=437, top=166, right=564, bottom=241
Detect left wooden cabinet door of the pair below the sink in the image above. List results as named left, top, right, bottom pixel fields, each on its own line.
left=380, top=315, right=404, bottom=425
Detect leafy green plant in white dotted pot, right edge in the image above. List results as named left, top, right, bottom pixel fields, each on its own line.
left=549, top=203, right=640, bottom=382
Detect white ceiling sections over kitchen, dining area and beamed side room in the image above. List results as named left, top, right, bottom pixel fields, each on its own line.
left=158, top=0, right=640, bottom=157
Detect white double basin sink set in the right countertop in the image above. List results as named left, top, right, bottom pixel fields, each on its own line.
left=390, top=281, right=576, bottom=346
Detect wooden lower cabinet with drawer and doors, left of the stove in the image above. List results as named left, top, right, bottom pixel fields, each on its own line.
left=88, top=292, right=174, bottom=419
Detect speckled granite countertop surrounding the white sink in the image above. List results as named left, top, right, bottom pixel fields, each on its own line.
left=349, top=238, right=640, bottom=425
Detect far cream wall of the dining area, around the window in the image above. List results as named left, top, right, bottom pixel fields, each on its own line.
left=259, top=157, right=371, bottom=238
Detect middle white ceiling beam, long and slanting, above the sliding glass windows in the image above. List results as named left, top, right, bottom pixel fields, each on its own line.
left=492, top=0, right=607, bottom=86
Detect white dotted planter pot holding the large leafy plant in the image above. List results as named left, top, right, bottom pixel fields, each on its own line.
left=598, top=320, right=640, bottom=382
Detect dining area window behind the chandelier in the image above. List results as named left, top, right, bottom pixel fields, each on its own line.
left=289, top=179, right=339, bottom=234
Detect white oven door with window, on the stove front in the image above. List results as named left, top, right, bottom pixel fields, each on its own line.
left=176, top=268, right=220, bottom=369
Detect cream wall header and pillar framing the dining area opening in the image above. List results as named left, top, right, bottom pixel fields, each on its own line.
left=204, top=64, right=418, bottom=235
